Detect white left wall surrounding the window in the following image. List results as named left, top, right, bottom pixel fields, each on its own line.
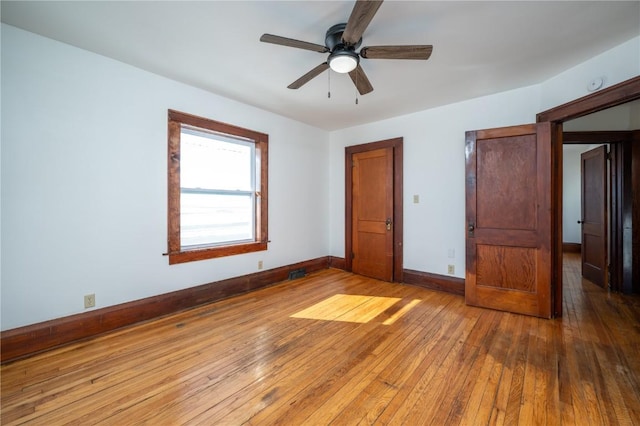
left=1, top=24, right=329, bottom=330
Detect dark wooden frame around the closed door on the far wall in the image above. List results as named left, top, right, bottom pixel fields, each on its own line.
left=344, top=137, right=404, bottom=282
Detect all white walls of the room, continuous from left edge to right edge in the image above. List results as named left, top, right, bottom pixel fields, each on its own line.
left=0, top=25, right=640, bottom=330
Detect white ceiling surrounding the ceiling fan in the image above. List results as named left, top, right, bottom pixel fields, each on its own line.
left=1, top=0, right=640, bottom=130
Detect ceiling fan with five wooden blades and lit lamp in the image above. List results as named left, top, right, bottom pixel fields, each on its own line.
left=260, top=0, right=433, bottom=95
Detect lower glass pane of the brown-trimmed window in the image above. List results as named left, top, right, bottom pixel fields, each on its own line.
left=180, top=192, right=255, bottom=247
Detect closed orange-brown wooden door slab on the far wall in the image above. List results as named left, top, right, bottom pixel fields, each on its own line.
left=351, top=147, right=394, bottom=281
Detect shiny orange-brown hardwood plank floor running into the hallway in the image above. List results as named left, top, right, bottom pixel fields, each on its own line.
left=1, top=254, right=640, bottom=425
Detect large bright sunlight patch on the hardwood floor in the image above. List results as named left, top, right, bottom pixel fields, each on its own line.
left=291, top=294, right=404, bottom=323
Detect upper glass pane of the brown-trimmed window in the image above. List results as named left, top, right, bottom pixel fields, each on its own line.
left=180, top=129, right=255, bottom=191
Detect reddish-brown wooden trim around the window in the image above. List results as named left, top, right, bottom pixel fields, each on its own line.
left=167, top=109, right=269, bottom=265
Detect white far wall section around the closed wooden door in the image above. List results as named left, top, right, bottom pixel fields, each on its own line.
left=330, top=86, right=539, bottom=277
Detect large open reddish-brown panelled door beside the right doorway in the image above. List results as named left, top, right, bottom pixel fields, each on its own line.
left=465, top=123, right=555, bottom=318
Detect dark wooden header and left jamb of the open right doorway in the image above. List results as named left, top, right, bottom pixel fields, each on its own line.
left=536, top=76, right=640, bottom=317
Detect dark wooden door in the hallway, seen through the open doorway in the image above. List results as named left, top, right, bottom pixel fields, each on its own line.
left=580, top=145, right=608, bottom=288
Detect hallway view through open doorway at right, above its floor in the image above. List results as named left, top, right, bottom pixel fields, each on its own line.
left=563, top=105, right=640, bottom=293
